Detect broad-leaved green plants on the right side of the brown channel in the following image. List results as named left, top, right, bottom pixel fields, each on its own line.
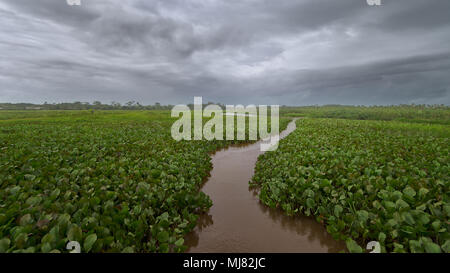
left=253, top=118, right=450, bottom=252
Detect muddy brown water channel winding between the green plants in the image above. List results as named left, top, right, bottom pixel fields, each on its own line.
left=185, top=121, right=345, bottom=253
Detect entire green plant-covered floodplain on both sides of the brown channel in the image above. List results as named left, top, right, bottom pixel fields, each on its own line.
left=0, top=105, right=450, bottom=253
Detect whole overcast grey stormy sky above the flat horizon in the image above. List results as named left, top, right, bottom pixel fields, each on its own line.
left=0, top=0, right=450, bottom=105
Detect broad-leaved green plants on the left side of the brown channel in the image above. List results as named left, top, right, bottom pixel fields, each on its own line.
left=0, top=111, right=288, bottom=252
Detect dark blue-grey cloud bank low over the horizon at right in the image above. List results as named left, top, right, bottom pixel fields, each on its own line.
left=268, top=54, right=450, bottom=104
